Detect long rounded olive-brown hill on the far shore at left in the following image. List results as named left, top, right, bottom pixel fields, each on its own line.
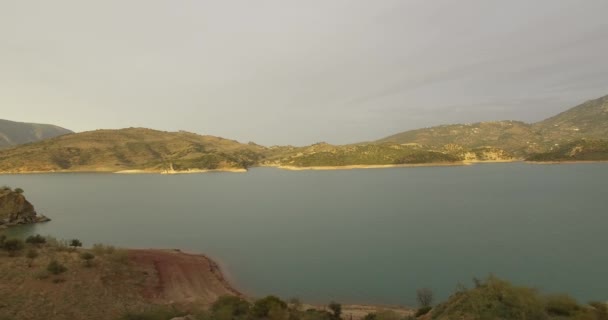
left=0, top=128, right=265, bottom=172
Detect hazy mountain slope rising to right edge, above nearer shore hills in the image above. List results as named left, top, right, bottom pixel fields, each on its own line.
left=376, top=96, right=608, bottom=157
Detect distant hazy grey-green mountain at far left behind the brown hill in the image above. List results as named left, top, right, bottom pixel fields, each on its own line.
left=0, top=119, right=73, bottom=149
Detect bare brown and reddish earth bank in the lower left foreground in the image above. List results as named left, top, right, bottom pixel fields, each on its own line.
left=0, top=245, right=238, bottom=320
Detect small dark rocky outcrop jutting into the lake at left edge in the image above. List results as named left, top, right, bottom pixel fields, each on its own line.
left=0, top=188, right=49, bottom=228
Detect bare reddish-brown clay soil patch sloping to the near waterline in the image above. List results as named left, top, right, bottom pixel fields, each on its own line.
left=129, top=250, right=242, bottom=304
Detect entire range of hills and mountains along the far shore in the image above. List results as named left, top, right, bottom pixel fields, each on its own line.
left=0, top=96, right=608, bottom=173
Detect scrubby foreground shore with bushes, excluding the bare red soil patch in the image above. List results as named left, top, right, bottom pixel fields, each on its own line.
left=0, top=234, right=608, bottom=320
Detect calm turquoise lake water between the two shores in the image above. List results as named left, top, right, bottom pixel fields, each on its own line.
left=0, top=163, right=608, bottom=305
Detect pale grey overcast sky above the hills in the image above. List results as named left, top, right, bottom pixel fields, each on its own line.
left=0, top=0, right=608, bottom=145
